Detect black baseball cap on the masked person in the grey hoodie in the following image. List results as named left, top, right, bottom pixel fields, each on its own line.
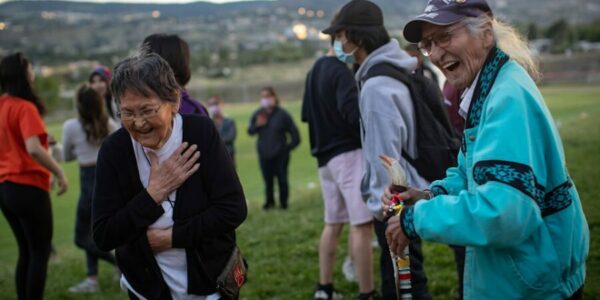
left=323, top=0, right=383, bottom=35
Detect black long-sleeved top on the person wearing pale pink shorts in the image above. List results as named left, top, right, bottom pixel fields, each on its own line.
left=302, top=56, right=360, bottom=167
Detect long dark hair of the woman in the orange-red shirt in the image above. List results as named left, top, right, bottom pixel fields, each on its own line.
left=0, top=52, right=46, bottom=115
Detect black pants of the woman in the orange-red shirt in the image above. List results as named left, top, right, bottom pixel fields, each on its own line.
left=0, top=181, right=52, bottom=300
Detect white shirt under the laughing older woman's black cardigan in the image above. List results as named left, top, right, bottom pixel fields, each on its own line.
left=121, top=114, right=220, bottom=300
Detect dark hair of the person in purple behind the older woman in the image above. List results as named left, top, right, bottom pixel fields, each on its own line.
left=142, top=33, right=192, bottom=87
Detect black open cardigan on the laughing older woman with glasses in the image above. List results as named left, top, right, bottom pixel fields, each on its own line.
left=92, top=115, right=247, bottom=299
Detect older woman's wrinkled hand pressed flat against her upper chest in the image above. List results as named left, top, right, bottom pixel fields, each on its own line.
left=147, top=142, right=200, bottom=204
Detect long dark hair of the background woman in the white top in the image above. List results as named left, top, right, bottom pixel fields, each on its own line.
left=77, top=84, right=108, bottom=144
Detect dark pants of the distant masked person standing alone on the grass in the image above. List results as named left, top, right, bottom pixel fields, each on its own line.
left=260, top=152, right=290, bottom=208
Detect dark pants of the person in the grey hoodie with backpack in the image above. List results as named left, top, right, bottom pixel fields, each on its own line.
left=374, top=220, right=431, bottom=300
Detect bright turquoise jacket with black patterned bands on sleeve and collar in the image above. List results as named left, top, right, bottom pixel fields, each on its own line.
left=402, top=60, right=589, bottom=300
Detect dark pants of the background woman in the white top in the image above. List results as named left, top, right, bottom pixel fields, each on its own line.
left=75, top=167, right=116, bottom=276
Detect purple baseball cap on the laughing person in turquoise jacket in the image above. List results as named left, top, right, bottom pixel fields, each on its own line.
left=404, top=0, right=492, bottom=43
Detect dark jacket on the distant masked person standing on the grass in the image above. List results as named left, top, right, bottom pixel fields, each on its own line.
left=248, top=106, right=300, bottom=159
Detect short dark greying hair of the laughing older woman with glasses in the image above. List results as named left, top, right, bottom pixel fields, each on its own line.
left=110, top=52, right=181, bottom=103
